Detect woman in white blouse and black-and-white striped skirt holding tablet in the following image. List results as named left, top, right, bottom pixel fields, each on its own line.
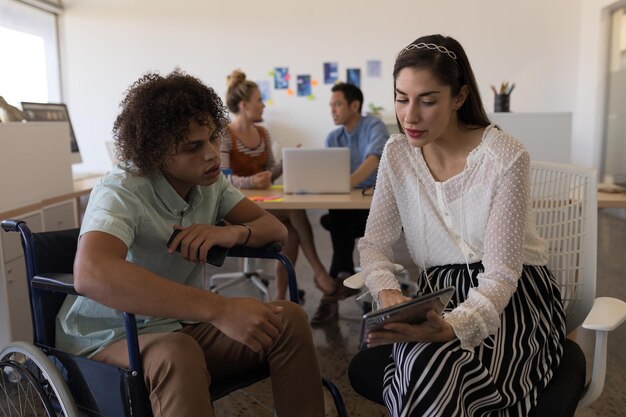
left=358, top=35, right=565, bottom=416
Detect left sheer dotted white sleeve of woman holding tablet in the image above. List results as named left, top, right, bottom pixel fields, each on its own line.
left=358, top=143, right=402, bottom=301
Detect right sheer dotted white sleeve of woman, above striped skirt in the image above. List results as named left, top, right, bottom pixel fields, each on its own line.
left=445, top=150, right=530, bottom=349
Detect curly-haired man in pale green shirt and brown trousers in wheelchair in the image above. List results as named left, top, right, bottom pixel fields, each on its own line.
left=56, top=71, right=324, bottom=417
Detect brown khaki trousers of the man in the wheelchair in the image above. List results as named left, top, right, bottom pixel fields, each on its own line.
left=93, top=301, right=324, bottom=417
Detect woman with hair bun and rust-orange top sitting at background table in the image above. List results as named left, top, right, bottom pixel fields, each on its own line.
left=220, top=70, right=335, bottom=300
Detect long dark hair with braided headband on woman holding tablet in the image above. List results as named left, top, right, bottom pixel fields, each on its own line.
left=393, top=35, right=491, bottom=132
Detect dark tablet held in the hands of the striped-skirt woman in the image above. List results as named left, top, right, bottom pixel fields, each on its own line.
left=361, top=287, right=454, bottom=347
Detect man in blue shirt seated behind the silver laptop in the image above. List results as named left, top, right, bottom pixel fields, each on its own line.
left=311, top=83, right=389, bottom=324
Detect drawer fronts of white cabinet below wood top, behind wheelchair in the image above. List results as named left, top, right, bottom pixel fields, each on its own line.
left=0, top=199, right=78, bottom=347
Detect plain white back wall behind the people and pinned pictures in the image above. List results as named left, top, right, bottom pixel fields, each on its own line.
left=60, top=0, right=580, bottom=171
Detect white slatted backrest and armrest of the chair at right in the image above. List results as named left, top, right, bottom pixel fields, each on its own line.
left=531, top=162, right=626, bottom=414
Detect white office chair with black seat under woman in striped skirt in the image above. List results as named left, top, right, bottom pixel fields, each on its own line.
left=348, top=162, right=626, bottom=417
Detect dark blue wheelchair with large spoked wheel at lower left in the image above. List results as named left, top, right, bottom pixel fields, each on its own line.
left=0, top=220, right=347, bottom=417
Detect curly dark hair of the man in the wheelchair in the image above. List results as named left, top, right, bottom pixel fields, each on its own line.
left=113, top=70, right=229, bottom=175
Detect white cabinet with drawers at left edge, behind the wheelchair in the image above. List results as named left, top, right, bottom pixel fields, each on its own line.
left=0, top=122, right=78, bottom=348
